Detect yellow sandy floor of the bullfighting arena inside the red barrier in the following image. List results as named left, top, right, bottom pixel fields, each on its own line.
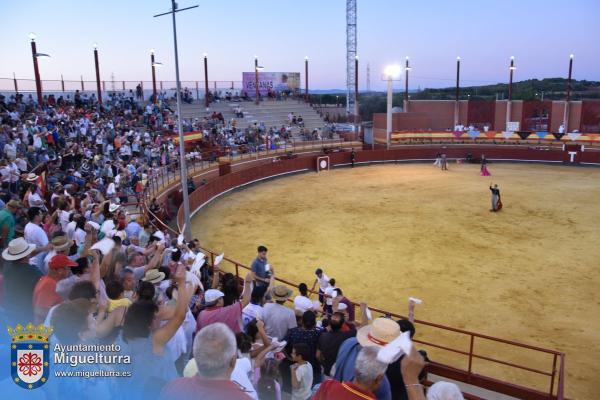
left=192, top=164, right=600, bottom=399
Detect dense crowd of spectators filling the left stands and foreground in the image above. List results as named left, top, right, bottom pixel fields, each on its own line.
left=0, top=95, right=462, bottom=400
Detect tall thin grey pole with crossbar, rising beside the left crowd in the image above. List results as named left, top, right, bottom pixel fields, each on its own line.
left=154, top=0, right=198, bottom=240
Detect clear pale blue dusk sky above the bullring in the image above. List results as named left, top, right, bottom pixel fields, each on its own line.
left=0, top=0, right=600, bottom=90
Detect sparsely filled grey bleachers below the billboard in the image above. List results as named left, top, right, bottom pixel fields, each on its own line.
left=181, top=100, right=325, bottom=134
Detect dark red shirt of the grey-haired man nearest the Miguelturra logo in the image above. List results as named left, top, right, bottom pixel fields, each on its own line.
left=160, top=375, right=251, bottom=400
